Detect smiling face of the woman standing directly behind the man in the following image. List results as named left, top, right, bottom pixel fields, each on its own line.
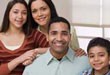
left=31, top=0, right=51, bottom=26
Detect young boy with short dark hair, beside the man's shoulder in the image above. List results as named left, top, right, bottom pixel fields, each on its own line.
left=82, top=37, right=110, bottom=75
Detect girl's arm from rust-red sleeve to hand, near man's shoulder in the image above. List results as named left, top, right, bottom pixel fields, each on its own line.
left=0, top=50, right=37, bottom=75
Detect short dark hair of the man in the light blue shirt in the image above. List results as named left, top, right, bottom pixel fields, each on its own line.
left=48, top=17, right=71, bottom=33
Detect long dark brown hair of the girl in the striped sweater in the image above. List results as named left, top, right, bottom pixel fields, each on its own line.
left=0, top=0, right=31, bottom=35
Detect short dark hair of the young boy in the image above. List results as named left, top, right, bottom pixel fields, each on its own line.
left=87, top=37, right=110, bottom=55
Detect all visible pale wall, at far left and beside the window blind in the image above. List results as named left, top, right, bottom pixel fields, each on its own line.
left=0, top=0, right=72, bottom=24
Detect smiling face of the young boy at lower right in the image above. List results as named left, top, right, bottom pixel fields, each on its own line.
left=88, top=46, right=110, bottom=71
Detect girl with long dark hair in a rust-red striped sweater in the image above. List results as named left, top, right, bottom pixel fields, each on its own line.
left=0, top=0, right=48, bottom=75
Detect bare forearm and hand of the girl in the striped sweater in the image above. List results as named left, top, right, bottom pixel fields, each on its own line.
left=8, top=50, right=37, bottom=72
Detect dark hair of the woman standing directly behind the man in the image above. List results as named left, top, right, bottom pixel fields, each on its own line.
left=28, top=0, right=58, bottom=28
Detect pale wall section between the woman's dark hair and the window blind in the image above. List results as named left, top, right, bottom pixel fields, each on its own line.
left=52, top=0, right=72, bottom=22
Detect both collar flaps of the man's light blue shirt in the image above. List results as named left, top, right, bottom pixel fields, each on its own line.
left=46, top=48, right=75, bottom=65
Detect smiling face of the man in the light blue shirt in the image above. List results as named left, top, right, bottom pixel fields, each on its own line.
left=48, top=22, right=71, bottom=53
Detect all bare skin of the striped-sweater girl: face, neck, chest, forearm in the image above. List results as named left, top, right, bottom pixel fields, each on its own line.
left=0, top=3, right=37, bottom=72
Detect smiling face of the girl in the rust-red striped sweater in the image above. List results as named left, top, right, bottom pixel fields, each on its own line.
left=9, top=3, right=27, bottom=28
